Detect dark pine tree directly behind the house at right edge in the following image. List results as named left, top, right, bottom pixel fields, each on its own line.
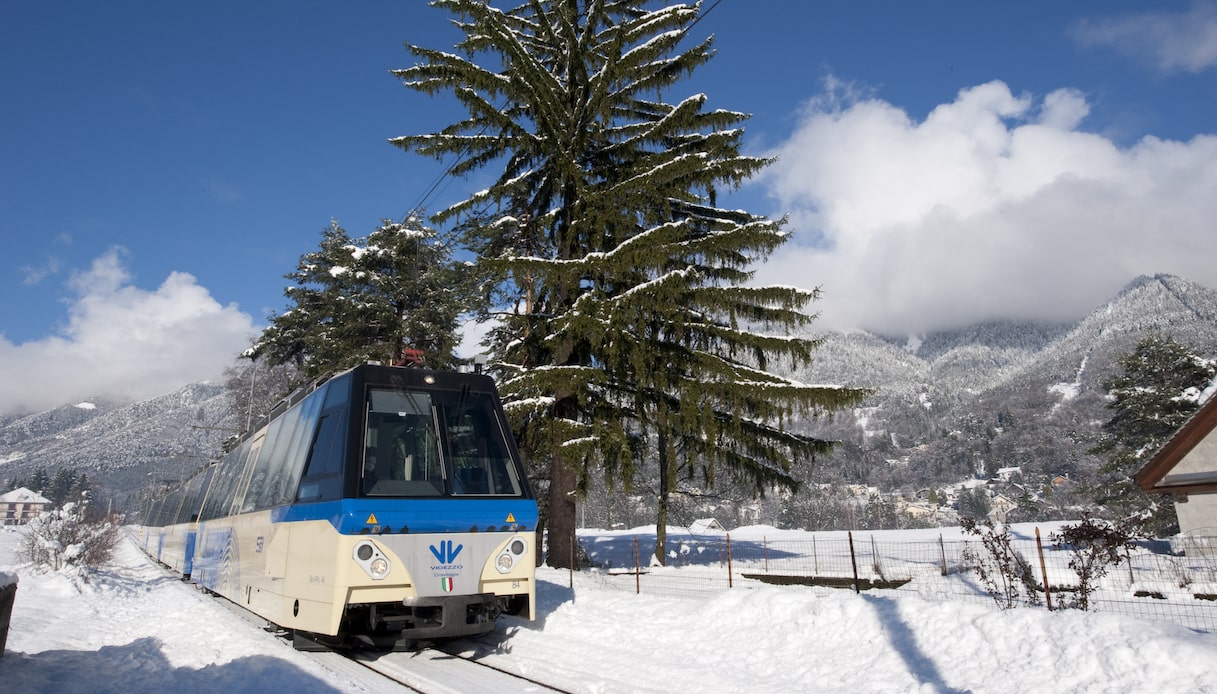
left=1092, top=334, right=1217, bottom=537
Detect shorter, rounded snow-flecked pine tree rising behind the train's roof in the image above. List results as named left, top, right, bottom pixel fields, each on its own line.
left=247, top=217, right=467, bottom=379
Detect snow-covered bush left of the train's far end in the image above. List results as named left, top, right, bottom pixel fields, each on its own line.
left=23, top=500, right=118, bottom=571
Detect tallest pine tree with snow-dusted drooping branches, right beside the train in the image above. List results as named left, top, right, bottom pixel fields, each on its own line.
left=394, top=0, right=864, bottom=566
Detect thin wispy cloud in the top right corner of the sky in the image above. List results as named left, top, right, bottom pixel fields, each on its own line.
left=1072, top=1, right=1217, bottom=72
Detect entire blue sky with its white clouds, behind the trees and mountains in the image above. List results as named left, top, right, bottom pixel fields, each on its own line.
left=0, top=0, right=1217, bottom=413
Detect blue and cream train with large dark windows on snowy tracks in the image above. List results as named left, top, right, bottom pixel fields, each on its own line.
left=135, top=363, right=538, bottom=650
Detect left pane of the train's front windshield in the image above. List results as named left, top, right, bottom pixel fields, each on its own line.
left=363, top=390, right=445, bottom=497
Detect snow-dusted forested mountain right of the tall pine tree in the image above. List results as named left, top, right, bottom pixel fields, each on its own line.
left=795, top=275, right=1217, bottom=489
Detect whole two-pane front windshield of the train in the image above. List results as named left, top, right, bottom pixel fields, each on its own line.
left=363, top=388, right=523, bottom=497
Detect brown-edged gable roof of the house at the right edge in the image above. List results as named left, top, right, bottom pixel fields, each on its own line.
left=1133, top=397, right=1217, bottom=493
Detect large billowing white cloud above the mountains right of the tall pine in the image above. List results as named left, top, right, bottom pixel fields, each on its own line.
left=758, top=82, right=1217, bottom=334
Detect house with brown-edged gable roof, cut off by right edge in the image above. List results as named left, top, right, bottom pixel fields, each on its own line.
left=1133, top=387, right=1217, bottom=536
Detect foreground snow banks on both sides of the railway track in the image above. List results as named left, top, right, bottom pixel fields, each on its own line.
left=0, top=521, right=1217, bottom=694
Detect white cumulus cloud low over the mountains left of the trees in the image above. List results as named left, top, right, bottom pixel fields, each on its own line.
left=0, top=248, right=257, bottom=413
